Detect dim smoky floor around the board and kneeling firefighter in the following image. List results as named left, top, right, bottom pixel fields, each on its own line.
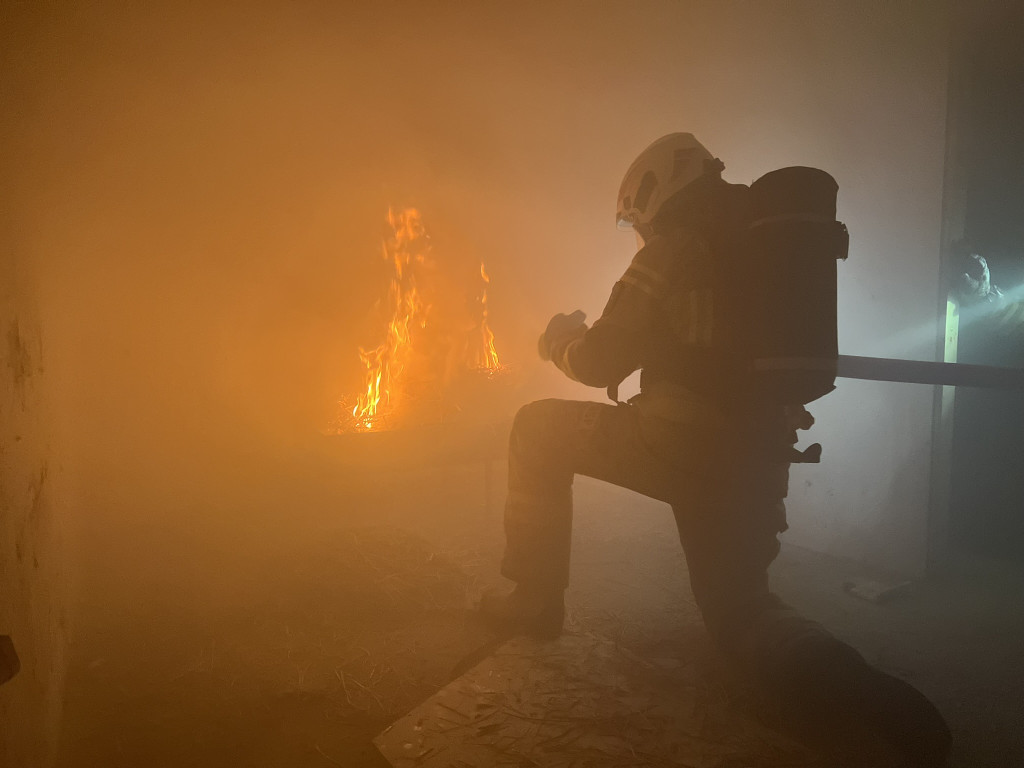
left=58, top=460, right=1024, bottom=768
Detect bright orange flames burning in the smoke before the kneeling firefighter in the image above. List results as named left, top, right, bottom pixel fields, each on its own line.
left=340, top=208, right=503, bottom=431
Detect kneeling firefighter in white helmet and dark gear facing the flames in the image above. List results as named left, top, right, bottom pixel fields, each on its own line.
left=480, top=133, right=949, bottom=766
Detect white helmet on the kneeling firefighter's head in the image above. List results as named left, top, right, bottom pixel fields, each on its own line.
left=615, top=133, right=715, bottom=229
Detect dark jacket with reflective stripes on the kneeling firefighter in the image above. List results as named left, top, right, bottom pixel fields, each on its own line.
left=551, top=207, right=794, bottom=454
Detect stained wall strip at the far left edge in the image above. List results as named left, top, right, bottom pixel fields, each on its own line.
left=0, top=256, right=66, bottom=768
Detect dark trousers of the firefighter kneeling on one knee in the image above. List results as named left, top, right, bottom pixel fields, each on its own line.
left=502, top=399, right=859, bottom=687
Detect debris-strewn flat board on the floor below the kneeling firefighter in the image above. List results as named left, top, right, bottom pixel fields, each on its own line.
left=375, top=634, right=820, bottom=768
